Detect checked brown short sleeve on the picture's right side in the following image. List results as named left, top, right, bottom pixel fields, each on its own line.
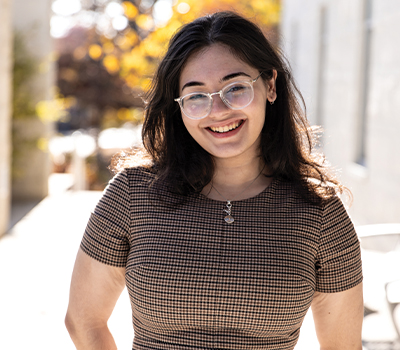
left=316, top=197, right=363, bottom=293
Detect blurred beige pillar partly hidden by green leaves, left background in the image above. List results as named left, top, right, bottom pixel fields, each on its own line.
left=12, top=0, right=54, bottom=201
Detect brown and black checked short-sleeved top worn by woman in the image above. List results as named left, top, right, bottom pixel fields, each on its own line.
left=81, top=168, right=362, bottom=350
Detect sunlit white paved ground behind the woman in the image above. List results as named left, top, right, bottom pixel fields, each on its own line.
left=0, top=183, right=393, bottom=350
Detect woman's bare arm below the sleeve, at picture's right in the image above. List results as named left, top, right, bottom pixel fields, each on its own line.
left=311, top=283, right=364, bottom=350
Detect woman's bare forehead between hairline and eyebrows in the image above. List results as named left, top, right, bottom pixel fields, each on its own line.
left=179, top=44, right=257, bottom=87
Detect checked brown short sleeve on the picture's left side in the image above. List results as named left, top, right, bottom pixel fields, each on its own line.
left=81, top=171, right=130, bottom=267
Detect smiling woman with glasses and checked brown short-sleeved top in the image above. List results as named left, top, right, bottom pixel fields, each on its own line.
left=66, top=12, right=363, bottom=350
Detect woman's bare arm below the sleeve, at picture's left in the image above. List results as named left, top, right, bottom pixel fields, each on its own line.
left=65, top=249, right=125, bottom=350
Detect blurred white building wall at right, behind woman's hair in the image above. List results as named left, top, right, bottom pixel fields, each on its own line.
left=278, top=0, right=400, bottom=224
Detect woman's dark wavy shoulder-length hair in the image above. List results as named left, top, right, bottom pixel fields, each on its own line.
left=116, top=12, right=344, bottom=203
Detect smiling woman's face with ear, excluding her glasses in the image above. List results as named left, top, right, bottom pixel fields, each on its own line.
left=179, top=44, right=275, bottom=164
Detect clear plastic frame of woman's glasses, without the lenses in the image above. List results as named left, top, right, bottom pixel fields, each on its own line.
left=174, top=72, right=262, bottom=120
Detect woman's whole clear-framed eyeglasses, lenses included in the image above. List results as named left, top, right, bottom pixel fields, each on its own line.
left=174, top=72, right=262, bottom=119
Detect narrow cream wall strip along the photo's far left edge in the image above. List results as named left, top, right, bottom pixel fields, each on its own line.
left=0, top=0, right=12, bottom=236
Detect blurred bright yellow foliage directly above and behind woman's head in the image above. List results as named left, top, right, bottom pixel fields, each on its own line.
left=94, top=0, right=280, bottom=94
